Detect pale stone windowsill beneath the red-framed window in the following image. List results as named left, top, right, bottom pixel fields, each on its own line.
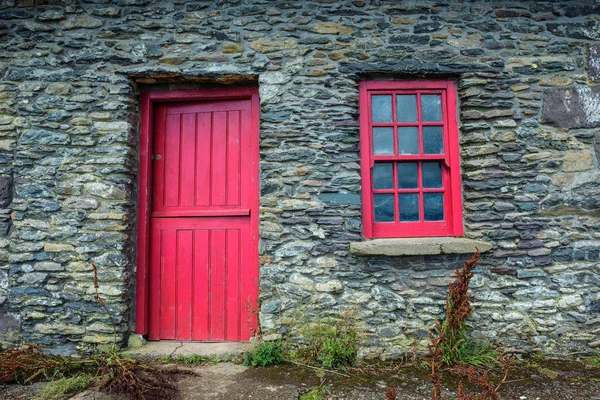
left=350, top=237, right=492, bottom=256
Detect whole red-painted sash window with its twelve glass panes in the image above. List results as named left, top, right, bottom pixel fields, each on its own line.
left=360, top=81, right=463, bottom=238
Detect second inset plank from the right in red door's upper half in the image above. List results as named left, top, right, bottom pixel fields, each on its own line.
left=210, top=112, right=227, bottom=206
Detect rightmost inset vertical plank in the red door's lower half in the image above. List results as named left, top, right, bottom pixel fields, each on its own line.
left=225, top=229, right=240, bottom=341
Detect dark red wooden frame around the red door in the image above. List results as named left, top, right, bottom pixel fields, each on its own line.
left=135, top=87, right=260, bottom=335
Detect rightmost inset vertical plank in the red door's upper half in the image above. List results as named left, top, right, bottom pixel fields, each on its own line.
left=226, top=111, right=242, bottom=206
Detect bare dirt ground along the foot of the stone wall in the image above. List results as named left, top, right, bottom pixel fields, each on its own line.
left=0, top=360, right=600, bottom=400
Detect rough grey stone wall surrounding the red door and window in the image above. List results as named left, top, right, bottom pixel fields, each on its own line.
left=0, top=0, right=600, bottom=358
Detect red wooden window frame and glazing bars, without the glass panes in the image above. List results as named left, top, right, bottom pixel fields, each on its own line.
left=359, top=80, right=463, bottom=238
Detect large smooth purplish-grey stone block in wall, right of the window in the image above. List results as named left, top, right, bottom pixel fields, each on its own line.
left=542, top=87, right=600, bottom=128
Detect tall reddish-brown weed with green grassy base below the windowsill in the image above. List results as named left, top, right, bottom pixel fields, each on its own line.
left=425, top=251, right=513, bottom=400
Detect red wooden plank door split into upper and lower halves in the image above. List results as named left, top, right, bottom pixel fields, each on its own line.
left=148, top=99, right=258, bottom=341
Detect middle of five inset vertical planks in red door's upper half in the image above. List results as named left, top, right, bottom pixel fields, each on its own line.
left=195, top=113, right=212, bottom=205
